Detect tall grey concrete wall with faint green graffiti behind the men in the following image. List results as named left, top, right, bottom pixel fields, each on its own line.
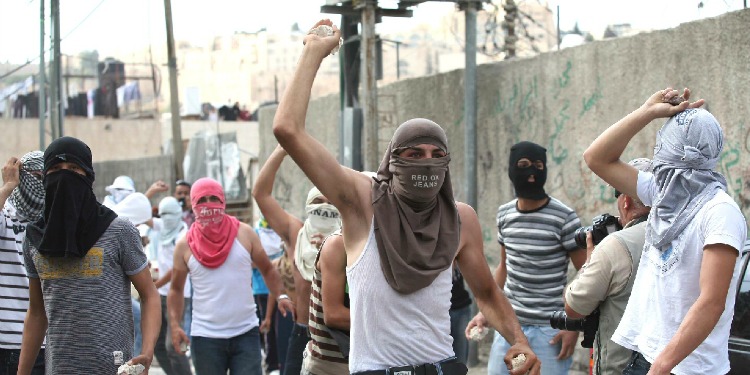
left=259, top=10, right=750, bottom=264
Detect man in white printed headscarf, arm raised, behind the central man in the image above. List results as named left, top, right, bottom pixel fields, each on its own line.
left=253, top=146, right=341, bottom=374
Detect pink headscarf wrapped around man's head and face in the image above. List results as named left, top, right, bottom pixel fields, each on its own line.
left=187, top=177, right=240, bottom=268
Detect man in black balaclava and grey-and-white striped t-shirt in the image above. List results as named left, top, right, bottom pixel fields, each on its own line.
left=469, top=141, right=586, bottom=375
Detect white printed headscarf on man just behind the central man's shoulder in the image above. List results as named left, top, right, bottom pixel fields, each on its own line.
left=294, top=187, right=341, bottom=281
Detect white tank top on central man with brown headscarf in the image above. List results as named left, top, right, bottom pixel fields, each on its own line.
left=346, top=223, right=453, bottom=373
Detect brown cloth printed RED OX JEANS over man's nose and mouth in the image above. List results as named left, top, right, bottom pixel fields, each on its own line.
left=388, top=155, right=450, bottom=210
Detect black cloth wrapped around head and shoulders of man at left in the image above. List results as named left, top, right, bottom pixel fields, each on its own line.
left=27, top=137, right=117, bottom=257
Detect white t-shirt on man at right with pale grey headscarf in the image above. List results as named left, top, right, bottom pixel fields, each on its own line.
left=612, top=172, right=747, bottom=375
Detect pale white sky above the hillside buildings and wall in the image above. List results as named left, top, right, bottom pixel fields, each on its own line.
left=0, top=0, right=743, bottom=63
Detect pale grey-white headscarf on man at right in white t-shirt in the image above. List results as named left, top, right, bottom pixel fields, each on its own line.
left=646, top=109, right=727, bottom=250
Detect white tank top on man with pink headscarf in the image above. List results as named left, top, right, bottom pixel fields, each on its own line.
left=188, top=238, right=259, bottom=339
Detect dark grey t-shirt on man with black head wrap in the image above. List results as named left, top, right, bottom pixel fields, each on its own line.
left=23, top=218, right=148, bottom=375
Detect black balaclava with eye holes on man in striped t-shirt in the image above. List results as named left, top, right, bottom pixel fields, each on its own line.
left=508, top=141, right=547, bottom=200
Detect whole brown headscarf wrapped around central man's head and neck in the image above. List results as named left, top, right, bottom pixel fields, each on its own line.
left=372, top=118, right=461, bottom=294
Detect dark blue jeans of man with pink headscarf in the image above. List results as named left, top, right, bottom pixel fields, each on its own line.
left=190, top=327, right=263, bottom=375
